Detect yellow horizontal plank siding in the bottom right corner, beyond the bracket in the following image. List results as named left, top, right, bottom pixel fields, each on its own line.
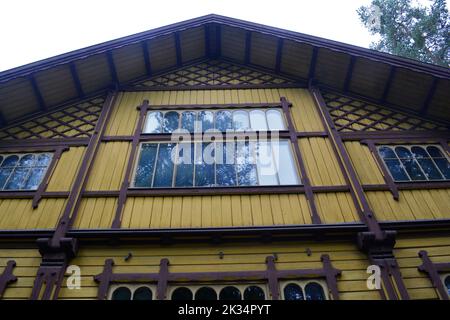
left=394, top=237, right=450, bottom=299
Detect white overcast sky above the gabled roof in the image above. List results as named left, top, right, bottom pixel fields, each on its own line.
left=0, top=0, right=432, bottom=71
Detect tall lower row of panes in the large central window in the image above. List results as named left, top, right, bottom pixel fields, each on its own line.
left=132, top=139, right=300, bottom=188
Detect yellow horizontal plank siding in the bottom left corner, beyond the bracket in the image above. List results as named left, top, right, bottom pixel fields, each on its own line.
left=0, top=244, right=41, bottom=300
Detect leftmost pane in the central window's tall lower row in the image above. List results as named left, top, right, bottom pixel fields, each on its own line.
left=134, top=143, right=158, bottom=188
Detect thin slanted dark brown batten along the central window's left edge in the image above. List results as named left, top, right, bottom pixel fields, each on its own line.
left=112, top=100, right=149, bottom=228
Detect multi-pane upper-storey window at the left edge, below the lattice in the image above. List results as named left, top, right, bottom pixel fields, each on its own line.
left=0, top=153, right=53, bottom=191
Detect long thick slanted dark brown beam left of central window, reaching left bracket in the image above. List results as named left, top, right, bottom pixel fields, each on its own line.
left=50, top=93, right=116, bottom=247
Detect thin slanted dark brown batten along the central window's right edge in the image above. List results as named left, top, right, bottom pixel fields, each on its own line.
left=280, top=97, right=322, bottom=224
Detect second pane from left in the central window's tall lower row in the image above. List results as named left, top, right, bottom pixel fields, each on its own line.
left=153, top=143, right=176, bottom=187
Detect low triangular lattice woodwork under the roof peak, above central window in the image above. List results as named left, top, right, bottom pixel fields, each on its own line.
left=133, top=60, right=294, bottom=88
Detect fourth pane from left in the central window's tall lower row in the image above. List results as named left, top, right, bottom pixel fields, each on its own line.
left=195, top=142, right=215, bottom=187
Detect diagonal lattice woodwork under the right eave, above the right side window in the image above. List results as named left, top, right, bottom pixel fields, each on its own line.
left=323, top=92, right=448, bottom=132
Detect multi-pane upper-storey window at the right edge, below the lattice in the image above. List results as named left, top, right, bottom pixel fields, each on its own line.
left=378, top=145, right=450, bottom=182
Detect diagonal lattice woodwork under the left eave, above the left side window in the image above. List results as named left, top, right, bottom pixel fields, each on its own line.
left=0, top=97, right=105, bottom=140
